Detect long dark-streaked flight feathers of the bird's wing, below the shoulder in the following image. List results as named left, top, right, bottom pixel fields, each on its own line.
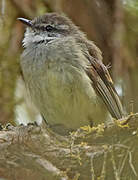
left=86, top=57, right=123, bottom=119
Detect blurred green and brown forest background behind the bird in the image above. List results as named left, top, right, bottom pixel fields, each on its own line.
left=0, top=0, right=138, bottom=124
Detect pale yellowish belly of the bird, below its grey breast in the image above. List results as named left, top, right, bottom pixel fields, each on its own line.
left=25, top=62, right=107, bottom=134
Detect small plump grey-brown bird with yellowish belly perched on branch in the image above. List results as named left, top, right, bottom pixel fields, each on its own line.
left=18, top=13, right=124, bottom=135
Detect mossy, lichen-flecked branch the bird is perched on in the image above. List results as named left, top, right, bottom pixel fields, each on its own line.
left=0, top=113, right=138, bottom=180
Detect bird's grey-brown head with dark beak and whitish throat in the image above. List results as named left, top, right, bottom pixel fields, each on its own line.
left=18, top=13, right=84, bottom=47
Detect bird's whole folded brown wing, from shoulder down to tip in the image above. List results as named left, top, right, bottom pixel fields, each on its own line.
left=77, top=38, right=124, bottom=119
